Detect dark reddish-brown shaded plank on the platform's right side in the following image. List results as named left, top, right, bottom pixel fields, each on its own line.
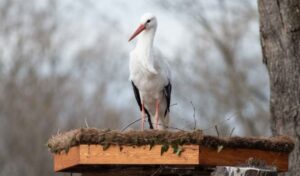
left=199, top=146, right=288, bottom=172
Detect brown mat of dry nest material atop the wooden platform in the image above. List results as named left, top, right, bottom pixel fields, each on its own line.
left=47, top=128, right=294, bottom=153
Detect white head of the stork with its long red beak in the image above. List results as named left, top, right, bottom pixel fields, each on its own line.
left=128, top=13, right=157, bottom=41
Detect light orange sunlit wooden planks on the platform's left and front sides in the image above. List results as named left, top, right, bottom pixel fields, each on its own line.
left=54, top=145, right=199, bottom=171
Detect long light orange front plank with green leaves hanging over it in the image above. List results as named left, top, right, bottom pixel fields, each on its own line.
left=80, top=145, right=199, bottom=165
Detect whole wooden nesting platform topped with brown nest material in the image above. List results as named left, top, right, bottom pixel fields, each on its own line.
left=48, top=128, right=294, bottom=175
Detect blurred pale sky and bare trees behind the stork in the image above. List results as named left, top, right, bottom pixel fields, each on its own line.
left=0, top=0, right=270, bottom=176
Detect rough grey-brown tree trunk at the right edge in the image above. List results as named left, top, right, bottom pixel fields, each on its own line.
left=258, top=0, right=300, bottom=175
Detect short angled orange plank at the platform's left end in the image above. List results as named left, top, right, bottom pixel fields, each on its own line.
left=54, top=146, right=79, bottom=172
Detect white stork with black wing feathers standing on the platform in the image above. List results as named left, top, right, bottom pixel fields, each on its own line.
left=129, top=13, right=172, bottom=130
